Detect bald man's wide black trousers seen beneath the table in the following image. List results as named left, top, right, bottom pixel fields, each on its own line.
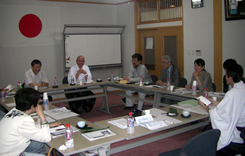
left=65, top=88, right=96, bottom=114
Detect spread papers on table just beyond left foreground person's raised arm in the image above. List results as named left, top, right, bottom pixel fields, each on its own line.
left=43, top=107, right=79, bottom=120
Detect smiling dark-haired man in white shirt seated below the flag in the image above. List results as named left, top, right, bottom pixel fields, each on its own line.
left=25, top=59, right=49, bottom=87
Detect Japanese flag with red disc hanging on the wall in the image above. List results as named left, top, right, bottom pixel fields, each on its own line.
left=0, top=5, right=61, bottom=47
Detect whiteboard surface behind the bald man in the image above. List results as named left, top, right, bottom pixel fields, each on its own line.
left=65, top=34, right=122, bottom=68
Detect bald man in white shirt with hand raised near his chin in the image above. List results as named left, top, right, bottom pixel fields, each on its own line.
left=68, top=55, right=92, bottom=83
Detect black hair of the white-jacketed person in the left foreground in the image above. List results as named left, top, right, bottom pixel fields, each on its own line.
left=14, top=88, right=40, bottom=111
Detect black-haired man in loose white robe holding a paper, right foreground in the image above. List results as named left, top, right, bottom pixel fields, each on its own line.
left=198, top=64, right=245, bottom=152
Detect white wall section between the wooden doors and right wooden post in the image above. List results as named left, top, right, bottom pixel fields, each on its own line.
left=183, top=1, right=214, bottom=83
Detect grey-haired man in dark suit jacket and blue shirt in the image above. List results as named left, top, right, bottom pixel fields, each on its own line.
left=156, top=55, right=181, bottom=86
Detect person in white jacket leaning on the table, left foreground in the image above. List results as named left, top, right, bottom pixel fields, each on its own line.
left=0, top=88, right=61, bottom=156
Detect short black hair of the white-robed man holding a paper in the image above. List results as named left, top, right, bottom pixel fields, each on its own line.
left=226, top=64, right=243, bottom=83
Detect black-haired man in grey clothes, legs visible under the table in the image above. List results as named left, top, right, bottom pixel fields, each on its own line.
left=122, top=53, right=152, bottom=110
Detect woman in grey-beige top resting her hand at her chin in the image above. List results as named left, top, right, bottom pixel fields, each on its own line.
left=185, top=58, right=213, bottom=91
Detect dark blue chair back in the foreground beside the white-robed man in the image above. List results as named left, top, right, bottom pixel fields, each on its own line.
left=158, top=129, right=220, bottom=156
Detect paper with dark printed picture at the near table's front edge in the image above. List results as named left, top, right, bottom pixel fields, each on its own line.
left=82, top=129, right=116, bottom=141
